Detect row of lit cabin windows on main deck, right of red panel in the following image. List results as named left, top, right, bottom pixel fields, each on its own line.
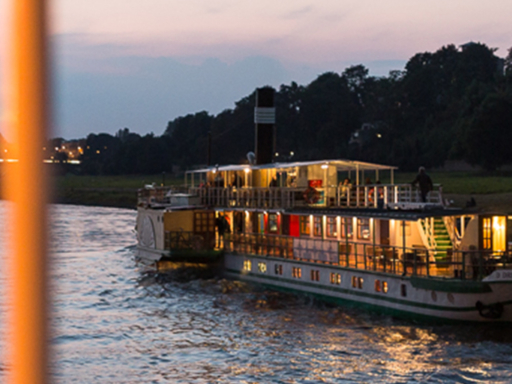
left=300, top=216, right=370, bottom=239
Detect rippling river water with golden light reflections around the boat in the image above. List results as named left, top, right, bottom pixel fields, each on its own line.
left=0, top=205, right=512, bottom=383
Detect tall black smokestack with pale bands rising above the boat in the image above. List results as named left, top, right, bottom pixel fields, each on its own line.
left=254, top=87, right=276, bottom=164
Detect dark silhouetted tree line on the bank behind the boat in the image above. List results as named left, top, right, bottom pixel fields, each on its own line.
left=73, top=43, right=512, bottom=174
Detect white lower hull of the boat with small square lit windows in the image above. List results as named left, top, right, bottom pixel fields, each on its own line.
left=224, top=253, right=512, bottom=322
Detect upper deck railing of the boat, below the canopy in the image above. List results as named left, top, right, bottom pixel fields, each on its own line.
left=138, top=184, right=443, bottom=209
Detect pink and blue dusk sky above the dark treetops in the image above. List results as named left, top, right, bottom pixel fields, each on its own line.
left=0, top=0, right=512, bottom=139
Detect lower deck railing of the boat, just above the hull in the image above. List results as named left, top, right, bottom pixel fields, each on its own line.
left=224, top=234, right=512, bottom=281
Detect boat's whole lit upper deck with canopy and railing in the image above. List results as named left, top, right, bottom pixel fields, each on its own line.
left=139, top=160, right=443, bottom=209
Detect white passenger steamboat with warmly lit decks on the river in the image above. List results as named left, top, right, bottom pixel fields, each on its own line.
left=137, top=156, right=512, bottom=322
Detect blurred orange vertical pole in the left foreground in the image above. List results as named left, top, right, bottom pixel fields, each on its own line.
left=5, top=0, right=50, bottom=384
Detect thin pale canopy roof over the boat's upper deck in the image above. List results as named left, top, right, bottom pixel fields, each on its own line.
left=186, top=159, right=398, bottom=173
